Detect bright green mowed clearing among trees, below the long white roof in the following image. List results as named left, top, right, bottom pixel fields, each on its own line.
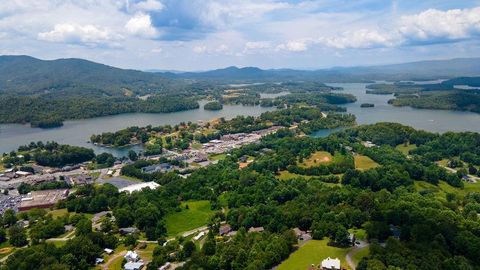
left=166, top=201, right=214, bottom=236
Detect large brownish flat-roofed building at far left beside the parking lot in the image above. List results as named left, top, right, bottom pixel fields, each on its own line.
left=18, top=189, right=68, bottom=211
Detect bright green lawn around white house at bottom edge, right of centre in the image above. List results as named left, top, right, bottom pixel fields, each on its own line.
left=278, top=239, right=350, bottom=270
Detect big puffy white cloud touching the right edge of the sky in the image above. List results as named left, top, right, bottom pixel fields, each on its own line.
left=399, top=7, right=480, bottom=41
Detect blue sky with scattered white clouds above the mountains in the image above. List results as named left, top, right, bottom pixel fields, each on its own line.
left=0, top=0, right=480, bottom=71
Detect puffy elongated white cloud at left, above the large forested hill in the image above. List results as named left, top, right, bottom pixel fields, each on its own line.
left=37, top=23, right=122, bottom=46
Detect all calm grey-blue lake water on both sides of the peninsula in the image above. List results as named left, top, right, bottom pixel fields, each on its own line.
left=0, top=83, right=480, bottom=156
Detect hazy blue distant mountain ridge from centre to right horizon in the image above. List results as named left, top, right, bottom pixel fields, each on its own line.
left=158, top=58, right=480, bottom=82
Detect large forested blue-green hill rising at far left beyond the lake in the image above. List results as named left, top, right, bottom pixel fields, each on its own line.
left=0, top=56, right=173, bottom=96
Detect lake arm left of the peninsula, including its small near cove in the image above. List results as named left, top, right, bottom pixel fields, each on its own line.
left=0, top=100, right=274, bottom=156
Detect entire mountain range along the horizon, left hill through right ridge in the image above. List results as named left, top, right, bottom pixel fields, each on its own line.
left=0, top=56, right=480, bottom=96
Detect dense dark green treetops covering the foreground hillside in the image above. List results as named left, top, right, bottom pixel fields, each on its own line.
left=0, top=123, right=480, bottom=270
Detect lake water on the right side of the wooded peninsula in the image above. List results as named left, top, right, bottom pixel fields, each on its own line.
left=312, top=83, right=480, bottom=137
